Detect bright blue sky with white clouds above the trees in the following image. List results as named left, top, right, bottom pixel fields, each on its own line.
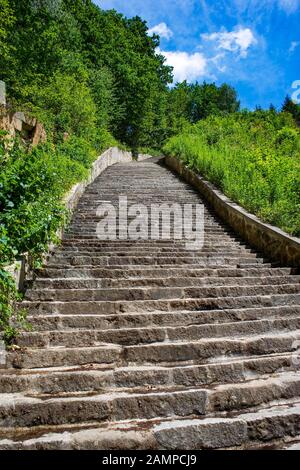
left=95, top=0, right=300, bottom=109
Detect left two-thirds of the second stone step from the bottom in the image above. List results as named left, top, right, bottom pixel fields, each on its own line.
left=0, top=390, right=206, bottom=427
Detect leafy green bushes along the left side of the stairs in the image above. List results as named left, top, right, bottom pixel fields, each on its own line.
left=0, top=131, right=113, bottom=343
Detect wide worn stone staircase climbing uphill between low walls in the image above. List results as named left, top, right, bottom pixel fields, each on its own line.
left=0, top=159, right=300, bottom=450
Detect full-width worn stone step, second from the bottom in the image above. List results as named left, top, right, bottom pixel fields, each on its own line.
left=0, top=372, right=300, bottom=428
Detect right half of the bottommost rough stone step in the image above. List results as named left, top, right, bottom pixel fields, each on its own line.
left=151, top=401, right=300, bottom=450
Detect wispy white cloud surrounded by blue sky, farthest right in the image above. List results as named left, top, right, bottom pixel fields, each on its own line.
left=202, top=26, right=257, bottom=57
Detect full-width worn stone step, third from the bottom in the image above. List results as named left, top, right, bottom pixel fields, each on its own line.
left=0, top=354, right=296, bottom=395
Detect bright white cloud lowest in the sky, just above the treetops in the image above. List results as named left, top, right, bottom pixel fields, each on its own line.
left=159, top=51, right=208, bottom=82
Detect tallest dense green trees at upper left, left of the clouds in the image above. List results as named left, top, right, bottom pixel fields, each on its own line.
left=0, top=0, right=172, bottom=147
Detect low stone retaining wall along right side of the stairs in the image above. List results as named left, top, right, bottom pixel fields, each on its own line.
left=164, top=156, right=300, bottom=267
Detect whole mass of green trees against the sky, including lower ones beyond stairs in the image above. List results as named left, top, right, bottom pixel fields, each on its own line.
left=0, top=0, right=300, bottom=148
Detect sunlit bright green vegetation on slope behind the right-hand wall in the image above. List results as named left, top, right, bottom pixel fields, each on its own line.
left=164, top=111, right=300, bottom=236
